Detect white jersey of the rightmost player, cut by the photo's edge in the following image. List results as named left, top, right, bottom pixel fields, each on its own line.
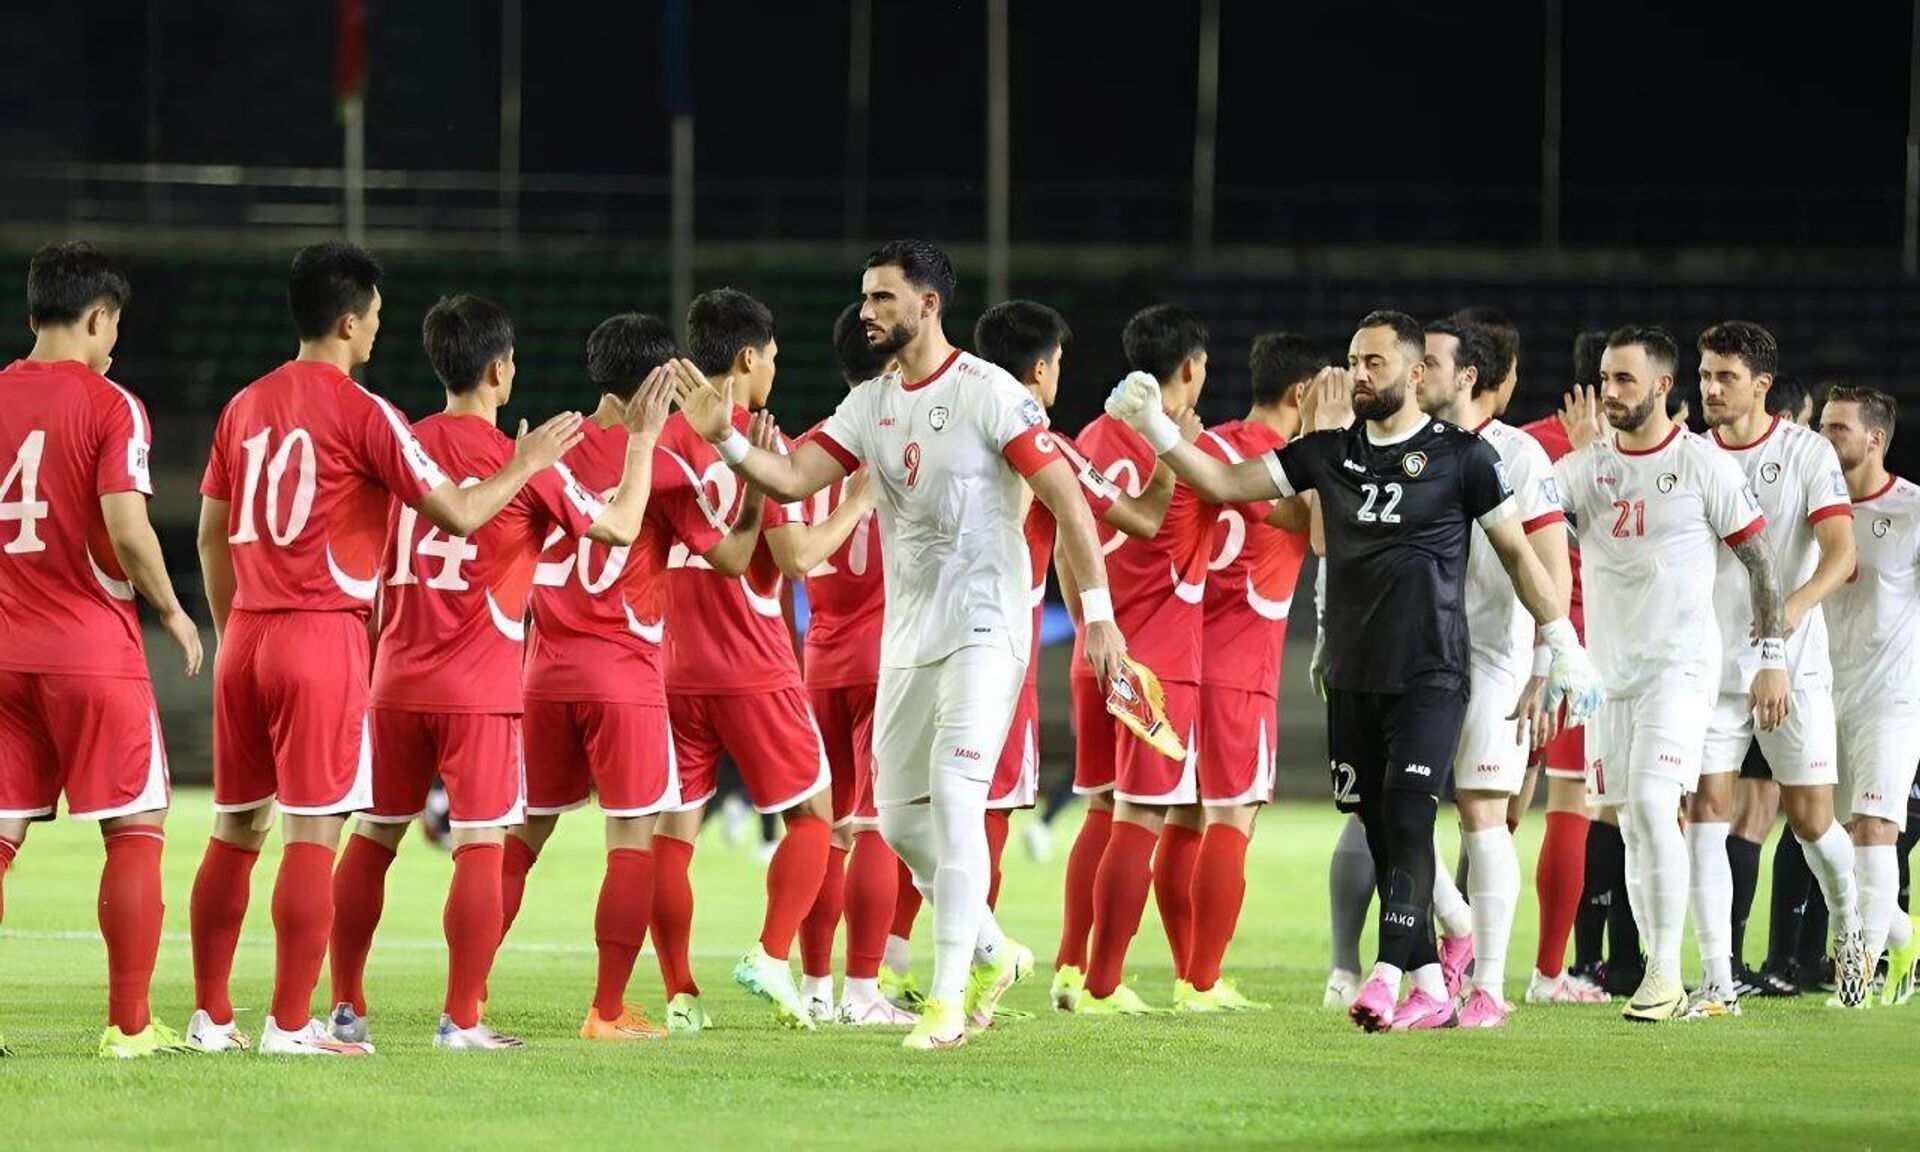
left=1826, top=478, right=1920, bottom=706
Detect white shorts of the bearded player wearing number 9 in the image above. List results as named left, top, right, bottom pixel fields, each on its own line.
left=874, top=643, right=1027, bottom=808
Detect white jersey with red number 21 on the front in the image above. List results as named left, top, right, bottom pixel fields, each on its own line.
left=1553, top=426, right=1766, bottom=699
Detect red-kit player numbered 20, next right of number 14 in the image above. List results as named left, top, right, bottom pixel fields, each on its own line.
left=501, top=313, right=760, bottom=1043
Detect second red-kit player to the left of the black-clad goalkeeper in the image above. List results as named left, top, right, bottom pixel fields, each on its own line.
left=1052, top=303, right=1219, bottom=1016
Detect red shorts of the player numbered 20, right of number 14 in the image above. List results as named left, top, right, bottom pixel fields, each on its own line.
left=520, top=701, right=680, bottom=816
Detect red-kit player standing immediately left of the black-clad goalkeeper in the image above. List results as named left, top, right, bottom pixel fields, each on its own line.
left=1173, top=332, right=1327, bottom=1012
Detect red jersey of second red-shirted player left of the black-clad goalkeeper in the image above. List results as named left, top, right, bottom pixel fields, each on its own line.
left=1073, top=415, right=1217, bottom=684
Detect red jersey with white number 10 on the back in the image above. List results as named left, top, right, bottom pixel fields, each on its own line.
left=200, top=361, right=447, bottom=612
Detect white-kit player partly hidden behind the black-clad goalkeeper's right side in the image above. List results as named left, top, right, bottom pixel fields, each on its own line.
left=1419, top=321, right=1572, bottom=1027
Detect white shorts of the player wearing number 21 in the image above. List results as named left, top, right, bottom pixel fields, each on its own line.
left=1586, top=672, right=1713, bottom=806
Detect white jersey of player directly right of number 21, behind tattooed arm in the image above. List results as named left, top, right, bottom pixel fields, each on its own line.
left=1711, top=417, right=1853, bottom=693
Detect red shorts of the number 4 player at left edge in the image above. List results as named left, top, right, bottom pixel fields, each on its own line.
left=0, top=670, right=167, bottom=820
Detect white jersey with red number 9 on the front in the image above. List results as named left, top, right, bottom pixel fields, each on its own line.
left=814, top=349, right=1060, bottom=668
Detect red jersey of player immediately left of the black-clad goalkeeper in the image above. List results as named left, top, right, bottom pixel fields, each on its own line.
left=1200, top=420, right=1308, bottom=695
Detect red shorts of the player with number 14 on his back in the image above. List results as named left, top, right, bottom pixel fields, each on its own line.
left=361, top=707, right=526, bottom=828
